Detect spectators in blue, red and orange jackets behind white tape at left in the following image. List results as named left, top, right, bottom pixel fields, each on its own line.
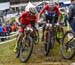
left=0, top=19, right=16, bottom=41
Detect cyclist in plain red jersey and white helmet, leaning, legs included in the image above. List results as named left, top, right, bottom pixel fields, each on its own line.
left=14, top=7, right=37, bottom=52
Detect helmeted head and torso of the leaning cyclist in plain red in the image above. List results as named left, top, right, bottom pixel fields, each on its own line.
left=19, top=7, right=37, bottom=32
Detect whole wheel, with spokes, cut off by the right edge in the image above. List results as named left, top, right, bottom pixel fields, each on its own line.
left=60, top=31, right=75, bottom=59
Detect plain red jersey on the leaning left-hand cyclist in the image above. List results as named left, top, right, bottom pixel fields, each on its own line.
left=19, top=11, right=37, bottom=25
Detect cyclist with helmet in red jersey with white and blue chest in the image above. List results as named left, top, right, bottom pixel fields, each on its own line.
left=38, top=2, right=61, bottom=40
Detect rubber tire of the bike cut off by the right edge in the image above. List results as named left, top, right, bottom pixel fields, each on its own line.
left=60, top=31, right=75, bottom=60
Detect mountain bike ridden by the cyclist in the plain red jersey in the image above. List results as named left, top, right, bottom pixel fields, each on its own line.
left=17, top=27, right=33, bottom=62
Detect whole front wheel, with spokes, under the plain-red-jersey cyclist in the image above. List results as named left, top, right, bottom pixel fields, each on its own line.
left=19, top=36, right=33, bottom=63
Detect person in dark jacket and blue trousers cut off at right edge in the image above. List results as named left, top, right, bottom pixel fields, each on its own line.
left=69, top=0, right=75, bottom=32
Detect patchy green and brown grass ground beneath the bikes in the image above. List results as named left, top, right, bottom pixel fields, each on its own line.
left=0, top=26, right=75, bottom=65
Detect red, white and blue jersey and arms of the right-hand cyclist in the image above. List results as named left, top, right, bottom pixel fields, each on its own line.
left=39, top=1, right=61, bottom=22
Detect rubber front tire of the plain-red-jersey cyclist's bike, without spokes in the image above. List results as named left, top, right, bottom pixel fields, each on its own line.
left=19, top=36, right=33, bottom=63
